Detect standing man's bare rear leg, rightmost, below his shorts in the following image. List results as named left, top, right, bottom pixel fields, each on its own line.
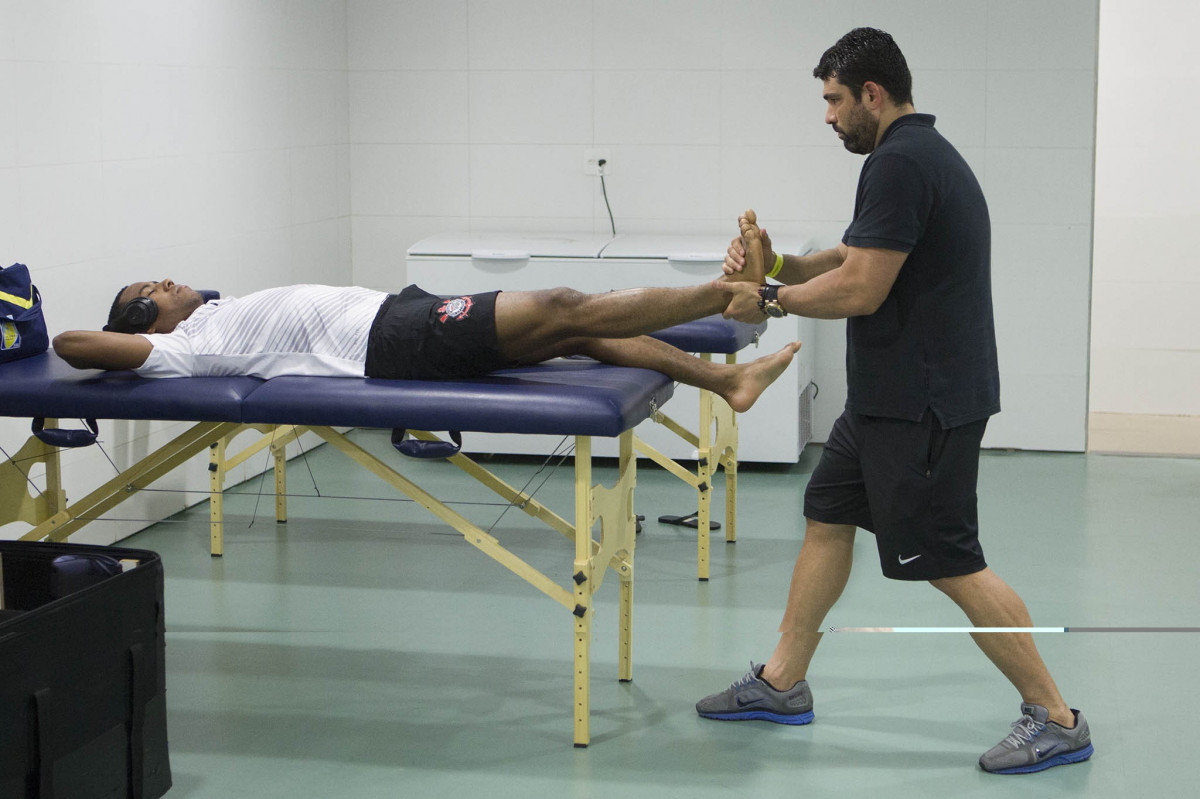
left=930, top=569, right=1075, bottom=729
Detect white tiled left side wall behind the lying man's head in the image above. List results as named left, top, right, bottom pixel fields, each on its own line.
left=0, top=0, right=352, bottom=542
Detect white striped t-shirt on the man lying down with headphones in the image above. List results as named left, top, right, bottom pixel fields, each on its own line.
left=134, top=286, right=388, bottom=378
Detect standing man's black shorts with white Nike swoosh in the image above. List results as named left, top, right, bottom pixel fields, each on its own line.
left=804, top=410, right=988, bottom=579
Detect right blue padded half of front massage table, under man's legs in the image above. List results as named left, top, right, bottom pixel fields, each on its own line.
left=242, top=360, right=674, bottom=435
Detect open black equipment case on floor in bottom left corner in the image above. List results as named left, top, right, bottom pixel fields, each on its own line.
left=0, top=541, right=170, bottom=799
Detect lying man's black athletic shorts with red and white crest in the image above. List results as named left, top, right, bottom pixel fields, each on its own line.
left=365, top=286, right=515, bottom=380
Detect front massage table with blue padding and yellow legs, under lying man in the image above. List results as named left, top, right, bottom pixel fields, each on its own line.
left=0, top=352, right=673, bottom=746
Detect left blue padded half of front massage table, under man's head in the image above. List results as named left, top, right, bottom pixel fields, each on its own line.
left=0, top=350, right=263, bottom=421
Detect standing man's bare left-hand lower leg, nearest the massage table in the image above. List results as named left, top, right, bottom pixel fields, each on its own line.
left=762, top=519, right=854, bottom=691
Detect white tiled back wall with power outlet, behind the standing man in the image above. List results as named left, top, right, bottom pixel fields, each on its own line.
left=348, top=0, right=1098, bottom=450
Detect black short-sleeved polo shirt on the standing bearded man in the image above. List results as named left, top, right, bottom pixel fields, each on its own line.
left=842, top=114, right=1000, bottom=427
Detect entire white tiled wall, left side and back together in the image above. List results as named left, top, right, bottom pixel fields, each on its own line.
left=0, top=0, right=1104, bottom=542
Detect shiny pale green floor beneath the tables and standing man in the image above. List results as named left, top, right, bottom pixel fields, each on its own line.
left=125, top=433, right=1200, bottom=799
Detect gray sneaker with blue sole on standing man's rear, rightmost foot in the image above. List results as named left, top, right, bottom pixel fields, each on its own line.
left=979, top=704, right=1092, bottom=774
